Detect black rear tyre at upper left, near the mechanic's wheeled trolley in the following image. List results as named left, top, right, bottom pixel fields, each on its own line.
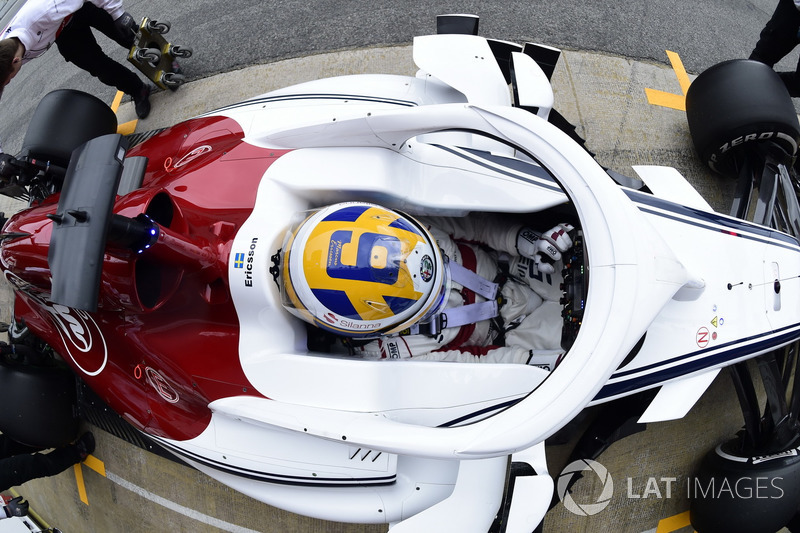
left=20, top=89, right=117, bottom=167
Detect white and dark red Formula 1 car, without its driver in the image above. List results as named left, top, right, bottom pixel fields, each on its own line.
left=0, top=16, right=800, bottom=533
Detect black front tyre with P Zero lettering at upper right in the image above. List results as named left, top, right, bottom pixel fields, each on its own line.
left=686, top=59, right=800, bottom=178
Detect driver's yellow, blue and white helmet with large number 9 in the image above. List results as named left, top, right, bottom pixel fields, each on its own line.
left=281, top=202, right=448, bottom=338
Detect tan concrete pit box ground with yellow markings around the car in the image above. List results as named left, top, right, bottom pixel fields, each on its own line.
left=0, top=5, right=792, bottom=533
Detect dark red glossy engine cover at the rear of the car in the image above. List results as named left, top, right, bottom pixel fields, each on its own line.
left=0, top=117, right=285, bottom=440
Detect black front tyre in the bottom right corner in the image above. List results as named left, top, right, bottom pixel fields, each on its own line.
left=686, top=441, right=800, bottom=533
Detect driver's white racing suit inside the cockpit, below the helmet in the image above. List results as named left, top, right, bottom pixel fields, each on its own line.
left=356, top=217, right=563, bottom=368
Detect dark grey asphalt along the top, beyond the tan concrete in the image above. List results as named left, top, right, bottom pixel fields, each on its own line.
left=0, top=0, right=798, bottom=153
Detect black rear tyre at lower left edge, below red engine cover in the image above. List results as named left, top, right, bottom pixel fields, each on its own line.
left=0, top=361, right=80, bottom=448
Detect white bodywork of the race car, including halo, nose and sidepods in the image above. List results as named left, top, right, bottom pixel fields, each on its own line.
left=147, top=30, right=800, bottom=532
